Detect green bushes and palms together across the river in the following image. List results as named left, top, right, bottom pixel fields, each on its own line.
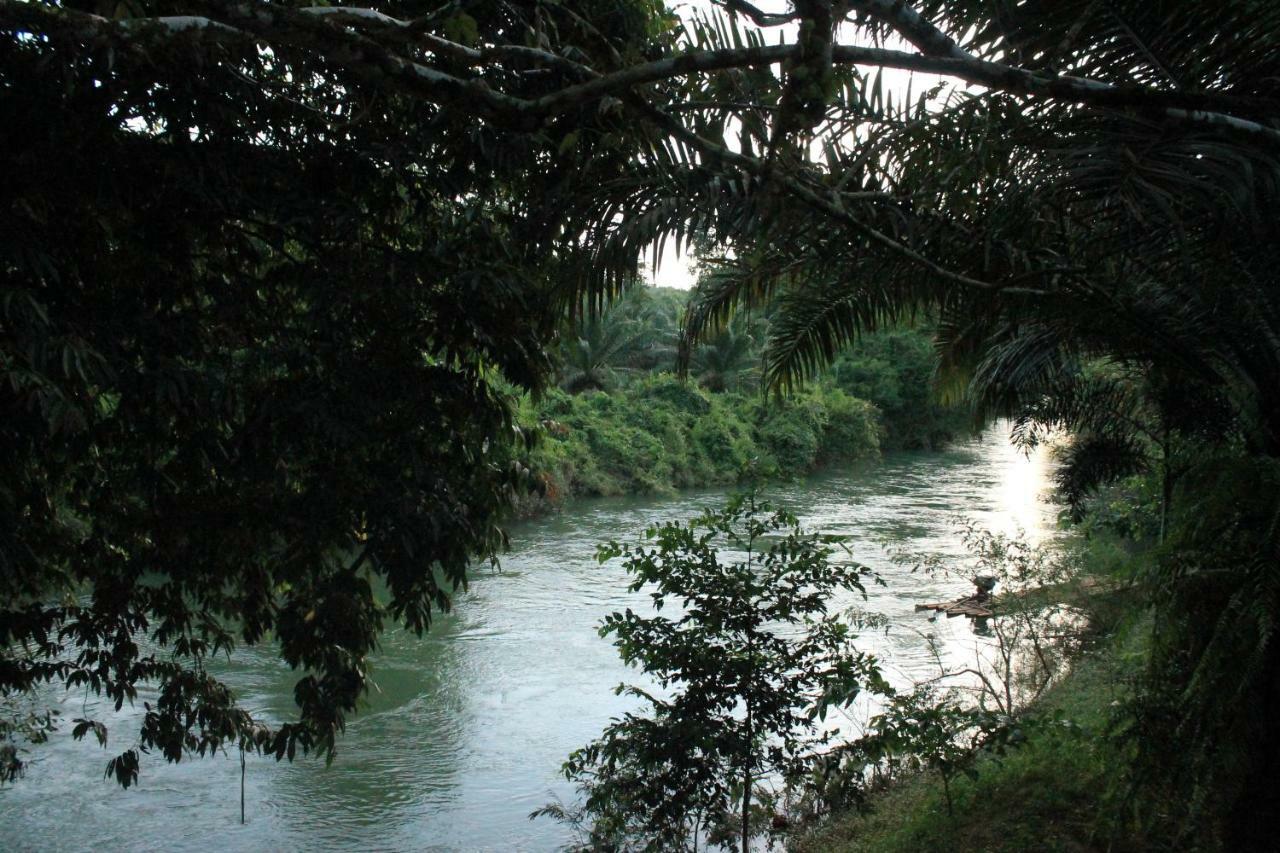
left=521, top=288, right=966, bottom=502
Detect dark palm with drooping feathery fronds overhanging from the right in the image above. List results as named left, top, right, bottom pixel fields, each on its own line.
left=565, top=0, right=1280, bottom=845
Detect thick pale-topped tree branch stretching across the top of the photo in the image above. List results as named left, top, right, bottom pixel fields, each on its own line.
left=0, top=0, right=1280, bottom=143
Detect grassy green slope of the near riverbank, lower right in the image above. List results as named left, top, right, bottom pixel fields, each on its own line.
left=787, top=542, right=1151, bottom=853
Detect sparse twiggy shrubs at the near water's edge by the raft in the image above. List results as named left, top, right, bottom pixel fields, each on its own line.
left=804, top=523, right=1088, bottom=820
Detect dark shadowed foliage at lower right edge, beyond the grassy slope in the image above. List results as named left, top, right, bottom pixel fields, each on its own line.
left=1115, top=457, right=1280, bottom=850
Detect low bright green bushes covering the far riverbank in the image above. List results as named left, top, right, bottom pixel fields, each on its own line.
left=509, top=374, right=886, bottom=517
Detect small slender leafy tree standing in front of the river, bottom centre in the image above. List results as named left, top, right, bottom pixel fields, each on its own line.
left=534, top=493, right=888, bottom=850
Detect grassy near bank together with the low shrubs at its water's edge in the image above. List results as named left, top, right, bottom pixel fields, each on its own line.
left=788, top=532, right=1146, bottom=853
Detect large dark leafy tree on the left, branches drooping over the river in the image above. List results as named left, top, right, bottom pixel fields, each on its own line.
left=0, top=3, right=670, bottom=785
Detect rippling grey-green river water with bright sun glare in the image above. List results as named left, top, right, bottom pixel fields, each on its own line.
left=0, top=429, right=1055, bottom=850
